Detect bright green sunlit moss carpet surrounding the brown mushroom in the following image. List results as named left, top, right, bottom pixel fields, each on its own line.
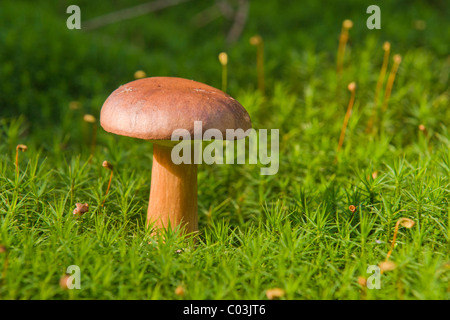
left=0, top=0, right=450, bottom=299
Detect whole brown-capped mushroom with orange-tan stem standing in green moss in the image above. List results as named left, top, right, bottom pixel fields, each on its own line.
left=100, top=77, right=251, bottom=234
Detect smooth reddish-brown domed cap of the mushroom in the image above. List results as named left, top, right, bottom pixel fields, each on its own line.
left=100, top=77, right=252, bottom=140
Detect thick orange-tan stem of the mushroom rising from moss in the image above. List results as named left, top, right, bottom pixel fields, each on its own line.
left=147, top=143, right=198, bottom=234
